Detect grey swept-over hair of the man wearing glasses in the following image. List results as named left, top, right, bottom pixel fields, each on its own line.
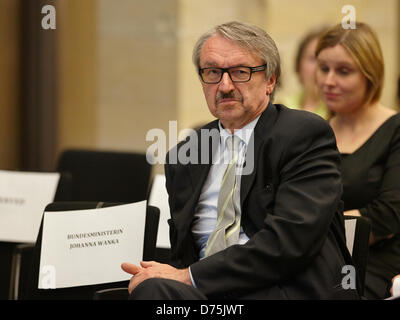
left=192, top=21, right=281, bottom=100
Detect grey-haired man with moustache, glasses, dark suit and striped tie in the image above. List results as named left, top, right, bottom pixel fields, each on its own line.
left=122, top=22, right=358, bottom=299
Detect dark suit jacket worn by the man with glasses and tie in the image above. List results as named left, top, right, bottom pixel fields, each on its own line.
left=165, top=103, right=357, bottom=299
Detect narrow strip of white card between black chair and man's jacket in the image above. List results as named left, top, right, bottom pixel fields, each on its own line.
left=149, top=174, right=171, bottom=248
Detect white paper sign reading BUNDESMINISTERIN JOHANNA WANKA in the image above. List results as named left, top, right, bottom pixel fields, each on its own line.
left=38, top=201, right=146, bottom=289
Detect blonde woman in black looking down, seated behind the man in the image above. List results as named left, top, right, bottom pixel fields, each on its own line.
left=316, top=23, right=400, bottom=299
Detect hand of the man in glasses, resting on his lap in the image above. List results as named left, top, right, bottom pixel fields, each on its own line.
left=121, top=261, right=192, bottom=293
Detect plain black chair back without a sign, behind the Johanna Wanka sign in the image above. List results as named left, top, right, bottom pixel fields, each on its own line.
left=56, top=150, right=151, bottom=203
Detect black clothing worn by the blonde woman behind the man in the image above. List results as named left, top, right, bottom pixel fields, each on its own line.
left=341, top=113, right=400, bottom=298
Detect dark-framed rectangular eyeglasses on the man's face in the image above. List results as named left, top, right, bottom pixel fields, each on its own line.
left=199, top=64, right=266, bottom=84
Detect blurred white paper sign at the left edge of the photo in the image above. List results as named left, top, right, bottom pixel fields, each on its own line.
left=0, top=170, right=60, bottom=243
